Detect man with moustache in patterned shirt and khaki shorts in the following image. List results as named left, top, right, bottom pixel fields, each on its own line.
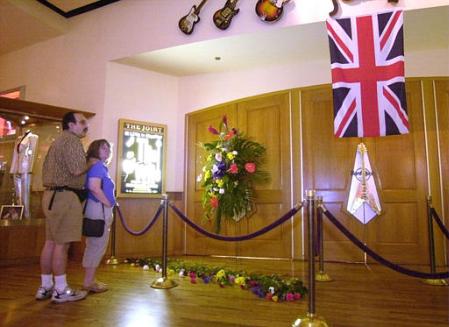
left=36, top=112, right=88, bottom=303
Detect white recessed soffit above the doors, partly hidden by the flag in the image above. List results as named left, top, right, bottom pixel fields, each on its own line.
left=117, top=6, right=449, bottom=76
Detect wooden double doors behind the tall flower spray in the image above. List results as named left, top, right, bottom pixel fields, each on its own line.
left=186, top=92, right=292, bottom=257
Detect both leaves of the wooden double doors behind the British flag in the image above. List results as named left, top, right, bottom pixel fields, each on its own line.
left=301, top=82, right=427, bottom=263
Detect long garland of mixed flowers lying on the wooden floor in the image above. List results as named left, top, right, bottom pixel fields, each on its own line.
left=125, top=258, right=307, bottom=302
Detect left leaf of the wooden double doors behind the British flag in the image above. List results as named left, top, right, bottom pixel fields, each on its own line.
left=301, top=86, right=363, bottom=262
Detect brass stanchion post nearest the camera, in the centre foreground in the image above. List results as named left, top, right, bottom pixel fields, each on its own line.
left=292, top=190, right=328, bottom=327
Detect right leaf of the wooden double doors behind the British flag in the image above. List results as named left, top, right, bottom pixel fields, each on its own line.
left=367, top=81, right=429, bottom=264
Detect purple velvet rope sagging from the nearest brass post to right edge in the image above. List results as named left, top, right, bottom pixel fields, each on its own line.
left=324, top=210, right=449, bottom=279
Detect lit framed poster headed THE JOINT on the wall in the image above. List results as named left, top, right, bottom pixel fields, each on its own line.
left=117, top=119, right=167, bottom=198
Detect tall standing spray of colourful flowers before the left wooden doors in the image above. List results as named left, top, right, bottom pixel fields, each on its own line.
left=197, top=116, right=268, bottom=233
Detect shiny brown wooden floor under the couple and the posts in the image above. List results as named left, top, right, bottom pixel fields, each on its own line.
left=0, top=257, right=449, bottom=327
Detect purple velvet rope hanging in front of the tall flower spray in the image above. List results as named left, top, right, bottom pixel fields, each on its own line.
left=169, top=204, right=302, bottom=242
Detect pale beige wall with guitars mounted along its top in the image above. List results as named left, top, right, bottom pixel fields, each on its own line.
left=0, top=0, right=449, bottom=191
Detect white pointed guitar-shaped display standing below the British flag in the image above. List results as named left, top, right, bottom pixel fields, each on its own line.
left=346, top=143, right=382, bottom=224
